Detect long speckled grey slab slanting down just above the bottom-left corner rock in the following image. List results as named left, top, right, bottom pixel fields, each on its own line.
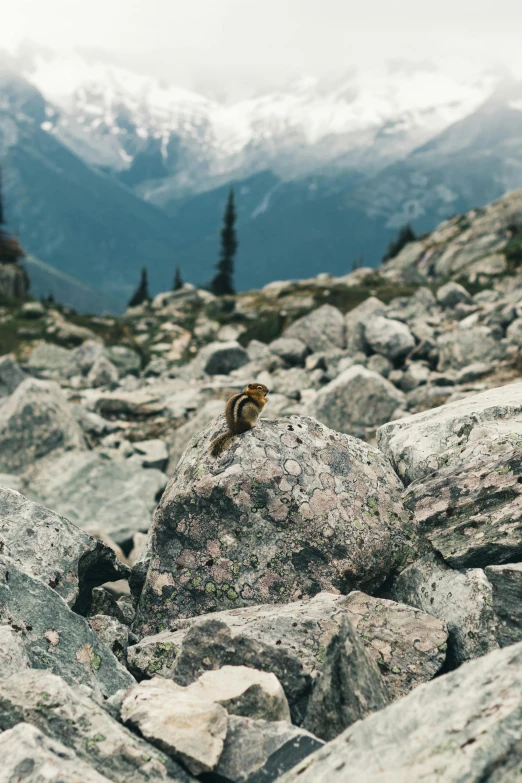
left=0, top=669, right=191, bottom=783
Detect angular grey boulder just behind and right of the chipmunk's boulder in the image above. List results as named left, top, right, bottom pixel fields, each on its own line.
left=309, top=364, right=406, bottom=437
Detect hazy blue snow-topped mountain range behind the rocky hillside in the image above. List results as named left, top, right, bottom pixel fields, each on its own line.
left=0, top=16, right=522, bottom=307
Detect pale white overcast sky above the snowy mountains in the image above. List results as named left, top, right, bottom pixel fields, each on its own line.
left=0, top=0, right=522, bottom=96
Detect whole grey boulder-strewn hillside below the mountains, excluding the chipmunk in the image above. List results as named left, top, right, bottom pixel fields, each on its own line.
left=0, top=193, right=522, bottom=783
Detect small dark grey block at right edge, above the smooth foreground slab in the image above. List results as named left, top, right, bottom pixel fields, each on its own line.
left=486, top=563, right=522, bottom=647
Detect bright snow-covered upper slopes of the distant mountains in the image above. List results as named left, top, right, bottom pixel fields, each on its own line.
left=15, top=44, right=499, bottom=201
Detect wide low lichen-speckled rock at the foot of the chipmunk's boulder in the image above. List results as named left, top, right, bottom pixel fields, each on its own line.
left=129, top=591, right=442, bottom=713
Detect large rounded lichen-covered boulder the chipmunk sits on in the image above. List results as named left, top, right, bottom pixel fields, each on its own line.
left=137, top=416, right=410, bottom=636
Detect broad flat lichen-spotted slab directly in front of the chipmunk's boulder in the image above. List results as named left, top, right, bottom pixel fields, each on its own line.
left=128, top=591, right=448, bottom=698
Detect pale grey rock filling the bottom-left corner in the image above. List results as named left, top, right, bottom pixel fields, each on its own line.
left=0, top=723, right=110, bottom=783
